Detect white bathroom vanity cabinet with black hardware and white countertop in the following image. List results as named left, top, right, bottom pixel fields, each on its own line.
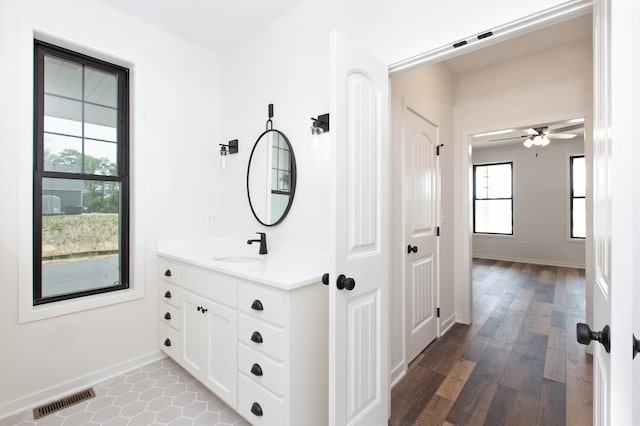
left=158, top=242, right=329, bottom=426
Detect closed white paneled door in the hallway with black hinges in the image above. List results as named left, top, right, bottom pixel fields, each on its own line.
left=402, top=105, right=439, bottom=364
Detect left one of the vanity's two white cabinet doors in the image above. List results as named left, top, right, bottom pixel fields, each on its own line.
left=181, top=291, right=209, bottom=381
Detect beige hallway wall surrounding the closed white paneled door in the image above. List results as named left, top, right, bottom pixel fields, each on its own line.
left=389, top=64, right=455, bottom=382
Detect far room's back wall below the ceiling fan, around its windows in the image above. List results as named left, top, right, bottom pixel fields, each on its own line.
left=473, top=137, right=585, bottom=268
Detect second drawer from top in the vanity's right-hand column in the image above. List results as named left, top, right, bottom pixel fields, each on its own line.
left=238, top=313, right=288, bottom=361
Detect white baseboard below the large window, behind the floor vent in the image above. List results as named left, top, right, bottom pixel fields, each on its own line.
left=0, top=350, right=166, bottom=419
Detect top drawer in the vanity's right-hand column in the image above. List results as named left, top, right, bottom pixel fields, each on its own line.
left=238, top=284, right=287, bottom=325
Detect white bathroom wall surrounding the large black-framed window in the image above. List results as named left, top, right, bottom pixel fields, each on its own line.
left=0, top=0, right=221, bottom=417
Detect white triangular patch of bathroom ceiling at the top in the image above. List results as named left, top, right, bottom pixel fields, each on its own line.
left=98, top=0, right=301, bottom=53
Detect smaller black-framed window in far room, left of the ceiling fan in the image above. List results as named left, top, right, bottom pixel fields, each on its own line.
left=473, top=162, right=513, bottom=235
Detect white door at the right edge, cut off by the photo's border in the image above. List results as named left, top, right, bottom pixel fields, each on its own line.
left=592, top=0, right=640, bottom=426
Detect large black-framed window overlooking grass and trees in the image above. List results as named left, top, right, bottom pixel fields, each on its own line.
left=33, top=40, right=129, bottom=305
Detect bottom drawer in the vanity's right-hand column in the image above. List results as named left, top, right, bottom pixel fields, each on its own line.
left=238, top=374, right=284, bottom=425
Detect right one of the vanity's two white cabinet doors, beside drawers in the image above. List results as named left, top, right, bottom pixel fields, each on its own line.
left=205, top=302, right=238, bottom=408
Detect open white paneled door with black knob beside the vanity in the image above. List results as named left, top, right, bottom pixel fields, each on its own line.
left=329, top=32, right=389, bottom=426
